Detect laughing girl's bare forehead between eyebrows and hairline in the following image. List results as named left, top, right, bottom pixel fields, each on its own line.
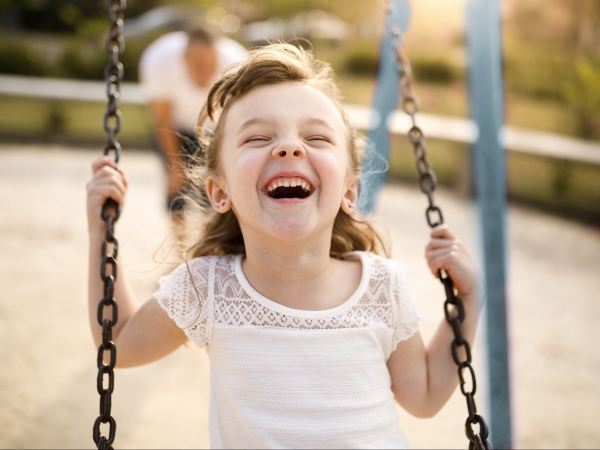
left=225, top=82, right=346, bottom=134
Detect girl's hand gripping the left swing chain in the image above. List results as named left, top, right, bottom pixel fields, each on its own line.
left=87, top=156, right=128, bottom=232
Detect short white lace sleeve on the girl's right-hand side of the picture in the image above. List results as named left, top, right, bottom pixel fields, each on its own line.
left=390, top=261, right=423, bottom=349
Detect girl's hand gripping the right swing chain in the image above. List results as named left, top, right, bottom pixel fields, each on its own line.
left=425, top=225, right=482, bottom=297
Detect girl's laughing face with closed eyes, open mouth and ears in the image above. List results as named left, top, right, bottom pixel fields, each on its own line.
left=207, top=82, right=357, bottom=241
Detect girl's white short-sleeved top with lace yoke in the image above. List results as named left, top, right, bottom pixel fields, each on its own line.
left=154, top=252, right=421, bottom=448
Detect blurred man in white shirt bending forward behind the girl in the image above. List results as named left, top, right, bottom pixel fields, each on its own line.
left=139, top=25, right=247, bottom=212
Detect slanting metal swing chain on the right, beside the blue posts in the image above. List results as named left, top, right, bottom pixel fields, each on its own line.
left=388, top=7, right=491, bottom=450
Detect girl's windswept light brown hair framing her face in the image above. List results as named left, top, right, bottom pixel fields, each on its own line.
left=187, top=44, right=389, bottom=258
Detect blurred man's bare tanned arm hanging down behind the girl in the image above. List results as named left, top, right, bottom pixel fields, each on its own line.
left=149, top=100, right=185, bottom=194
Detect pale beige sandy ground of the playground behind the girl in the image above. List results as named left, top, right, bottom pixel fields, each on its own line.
left=0, top=145, right=600, bottom=448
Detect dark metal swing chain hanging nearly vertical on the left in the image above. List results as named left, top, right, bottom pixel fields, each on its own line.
left=93, top=0, right=126, bottom=450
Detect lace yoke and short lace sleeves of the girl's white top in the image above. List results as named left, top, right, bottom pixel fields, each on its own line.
left=155, top=253, right=421, bottom=348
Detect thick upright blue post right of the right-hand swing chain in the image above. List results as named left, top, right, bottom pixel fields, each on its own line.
left=467, top=0, right=512, bottom=449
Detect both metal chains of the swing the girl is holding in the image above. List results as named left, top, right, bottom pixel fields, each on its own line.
left=93, top=0, right=491, bottom=450
